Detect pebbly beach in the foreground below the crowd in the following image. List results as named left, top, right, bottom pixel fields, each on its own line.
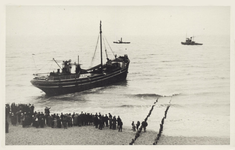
left=5, top=125, right=230, bottom=145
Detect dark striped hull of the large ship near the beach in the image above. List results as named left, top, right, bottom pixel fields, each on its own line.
left=31, top=67, right=128, bottom=96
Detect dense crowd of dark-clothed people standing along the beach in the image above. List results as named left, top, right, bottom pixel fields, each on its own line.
left=6, top=103, right=123, bottom=133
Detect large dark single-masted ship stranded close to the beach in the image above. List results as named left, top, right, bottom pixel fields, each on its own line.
left=31, top=21, right=130, bottom=96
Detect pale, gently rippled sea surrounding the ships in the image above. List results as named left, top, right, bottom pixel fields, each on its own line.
left=5, top=33, right=230, bottom=138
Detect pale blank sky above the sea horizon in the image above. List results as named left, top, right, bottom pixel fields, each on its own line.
left=6, top=5, right=231, bottom=36
